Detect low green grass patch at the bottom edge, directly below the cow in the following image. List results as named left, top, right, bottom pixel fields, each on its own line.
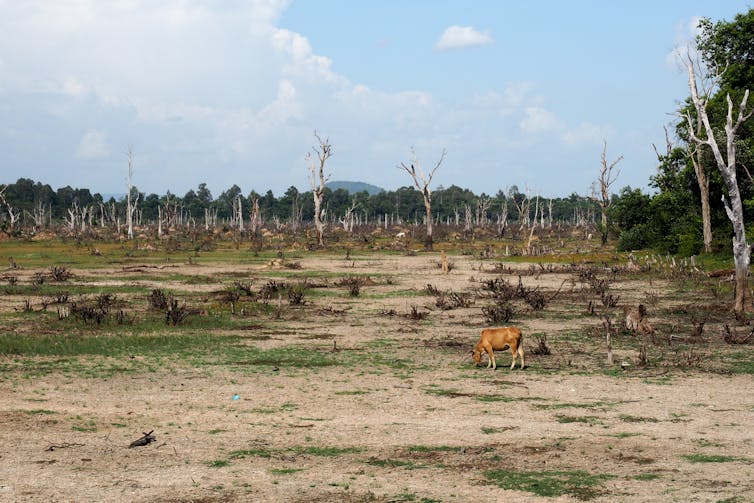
left=484, top=470, right=614, bottom=500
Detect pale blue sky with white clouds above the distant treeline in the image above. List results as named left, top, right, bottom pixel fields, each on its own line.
left=0, top=0, right=751, bottom=197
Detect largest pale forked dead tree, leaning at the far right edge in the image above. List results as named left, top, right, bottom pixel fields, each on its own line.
left=686, top=57, right=754, bottom=316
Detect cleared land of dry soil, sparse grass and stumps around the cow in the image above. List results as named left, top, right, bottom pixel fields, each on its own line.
left=0, top=241, right=754, bottom=502
